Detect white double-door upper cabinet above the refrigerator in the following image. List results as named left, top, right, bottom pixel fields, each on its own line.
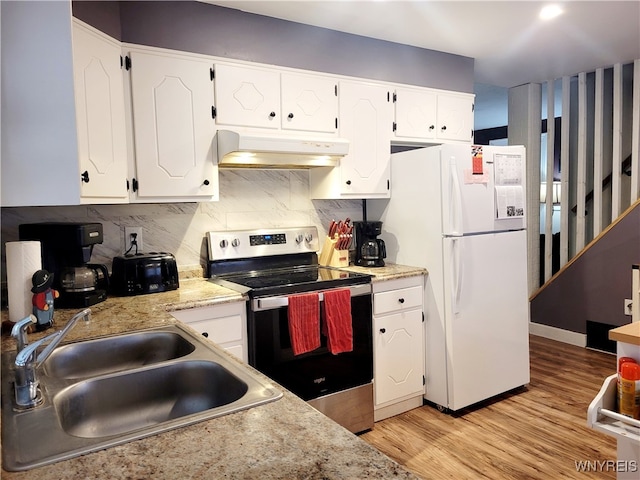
left=394, top=88, right=474, bottom=143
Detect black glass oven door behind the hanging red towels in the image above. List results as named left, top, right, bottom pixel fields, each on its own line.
left=248, top=283, right=373, bottom=400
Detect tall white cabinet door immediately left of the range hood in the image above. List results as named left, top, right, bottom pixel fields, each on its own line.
left=130, top=52, right=218, bottom=198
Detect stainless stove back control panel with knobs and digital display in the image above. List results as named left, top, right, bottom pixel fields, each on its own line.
left=206, top=227, right=320, bottom=261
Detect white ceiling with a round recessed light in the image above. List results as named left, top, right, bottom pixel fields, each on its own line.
left=207, top=0, right=640, bottom=87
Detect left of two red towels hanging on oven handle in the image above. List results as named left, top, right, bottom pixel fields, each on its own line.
left=288, top=293, right=320, bottom=355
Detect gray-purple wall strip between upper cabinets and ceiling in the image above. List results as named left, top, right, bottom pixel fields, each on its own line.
left=73, top=1, right=474, bottom=93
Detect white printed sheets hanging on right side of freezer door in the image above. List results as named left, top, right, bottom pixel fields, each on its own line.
left=493, top=153, right=524, bottom=219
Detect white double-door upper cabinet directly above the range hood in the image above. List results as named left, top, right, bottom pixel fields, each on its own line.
left=215, top=64, right=338, bottom=133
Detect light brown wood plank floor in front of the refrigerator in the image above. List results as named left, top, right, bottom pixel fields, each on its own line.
left=361, top=336, right=616, bottom=480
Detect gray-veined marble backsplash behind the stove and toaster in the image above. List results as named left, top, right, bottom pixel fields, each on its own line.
left=1, top=169, right=362, bottom=281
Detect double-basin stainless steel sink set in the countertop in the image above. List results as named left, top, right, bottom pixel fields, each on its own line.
left=2, top=325, right=282, bottom=471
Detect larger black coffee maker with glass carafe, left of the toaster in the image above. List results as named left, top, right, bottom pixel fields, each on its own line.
left=18, top=222, right=109, bottom=308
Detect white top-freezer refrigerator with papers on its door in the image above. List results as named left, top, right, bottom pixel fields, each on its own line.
left=367, top=145, right=530, bottom=411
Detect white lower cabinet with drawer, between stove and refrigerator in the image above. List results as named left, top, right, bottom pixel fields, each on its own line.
left=373, top=276, right=424, bottom=421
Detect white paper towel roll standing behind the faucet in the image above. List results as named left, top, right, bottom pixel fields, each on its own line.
left=5, top=241, right=42, bottom=322
